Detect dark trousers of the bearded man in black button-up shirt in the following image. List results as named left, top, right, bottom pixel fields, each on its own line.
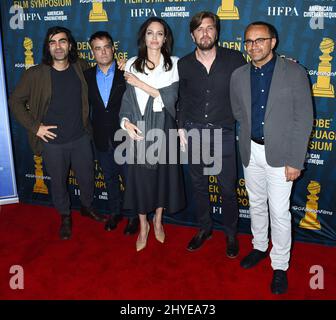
left=185, top=121, right=239, bottom=236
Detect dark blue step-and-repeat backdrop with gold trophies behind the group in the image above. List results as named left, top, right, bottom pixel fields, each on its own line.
left=1, top=0, right=336, bottom=245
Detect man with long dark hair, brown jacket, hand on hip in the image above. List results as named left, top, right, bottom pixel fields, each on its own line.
left=9, top=26, right=104, bottom=239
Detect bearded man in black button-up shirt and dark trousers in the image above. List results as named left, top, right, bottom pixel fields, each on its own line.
left=178, top=12, right=246, bottom=258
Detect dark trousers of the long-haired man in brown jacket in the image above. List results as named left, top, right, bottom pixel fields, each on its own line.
left=42, top=134, right=94, bottom=215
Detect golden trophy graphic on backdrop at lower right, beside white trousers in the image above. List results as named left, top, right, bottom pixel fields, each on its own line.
left=299, top=181, right=321, bottom=230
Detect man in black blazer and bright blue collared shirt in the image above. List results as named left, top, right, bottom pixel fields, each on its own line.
left=85, top=31, right=139, bottom=234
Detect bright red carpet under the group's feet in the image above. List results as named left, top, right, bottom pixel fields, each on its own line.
left=0, top=204, right=336, bottom=300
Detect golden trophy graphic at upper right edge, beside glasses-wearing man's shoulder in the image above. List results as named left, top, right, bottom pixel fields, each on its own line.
left=313, top=38, right=335, bottom=98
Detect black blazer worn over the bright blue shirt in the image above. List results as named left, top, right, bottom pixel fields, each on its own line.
left=84, top=66, right=126, bottom=151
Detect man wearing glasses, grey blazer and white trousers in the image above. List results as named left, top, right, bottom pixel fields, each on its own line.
left=230, top=22, right=313, bottom=294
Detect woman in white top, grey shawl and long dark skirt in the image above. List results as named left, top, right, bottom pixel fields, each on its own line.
left=120, top=17, right=185, bottom=251
